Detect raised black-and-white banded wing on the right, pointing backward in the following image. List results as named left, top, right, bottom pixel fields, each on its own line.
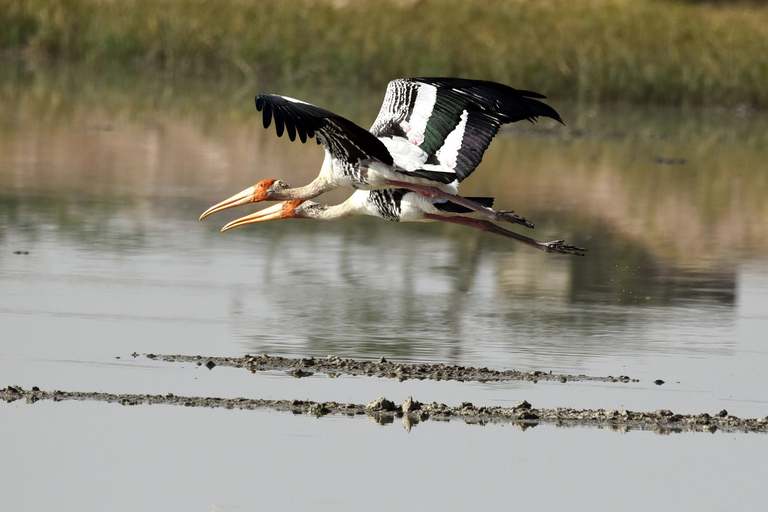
left=371, top=78, right=563, bottom=181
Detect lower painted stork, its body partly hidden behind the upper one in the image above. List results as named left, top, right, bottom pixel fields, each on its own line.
left=222, top=189, right=586, bottom=256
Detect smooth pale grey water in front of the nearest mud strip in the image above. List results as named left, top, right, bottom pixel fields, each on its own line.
left=6, top=402, right=768, bottom=511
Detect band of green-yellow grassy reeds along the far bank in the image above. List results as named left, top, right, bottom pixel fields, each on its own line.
left=0, top=0, right=768, bottom=107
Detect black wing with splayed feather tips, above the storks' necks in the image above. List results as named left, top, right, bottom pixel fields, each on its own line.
left=256, top=94, right=394, bottom=165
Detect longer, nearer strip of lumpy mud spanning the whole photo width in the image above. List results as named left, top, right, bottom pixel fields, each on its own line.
left=0, top=386, right=768, bottom=434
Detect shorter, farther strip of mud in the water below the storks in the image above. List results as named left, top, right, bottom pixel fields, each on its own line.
left=147, top=353, right=638, bottom=383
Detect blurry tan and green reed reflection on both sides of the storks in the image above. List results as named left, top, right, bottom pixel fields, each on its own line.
left=0, top=71, right=768, bottom=265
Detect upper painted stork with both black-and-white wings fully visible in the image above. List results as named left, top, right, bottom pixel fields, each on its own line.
left=200, top=78, right=563, bottom=227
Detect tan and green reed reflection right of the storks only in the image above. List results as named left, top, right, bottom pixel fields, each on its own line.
left=486, top=112, right=768, bottom=264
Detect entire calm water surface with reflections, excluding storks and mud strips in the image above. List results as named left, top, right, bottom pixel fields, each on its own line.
left=0, top=66, right=768, bottom=510
